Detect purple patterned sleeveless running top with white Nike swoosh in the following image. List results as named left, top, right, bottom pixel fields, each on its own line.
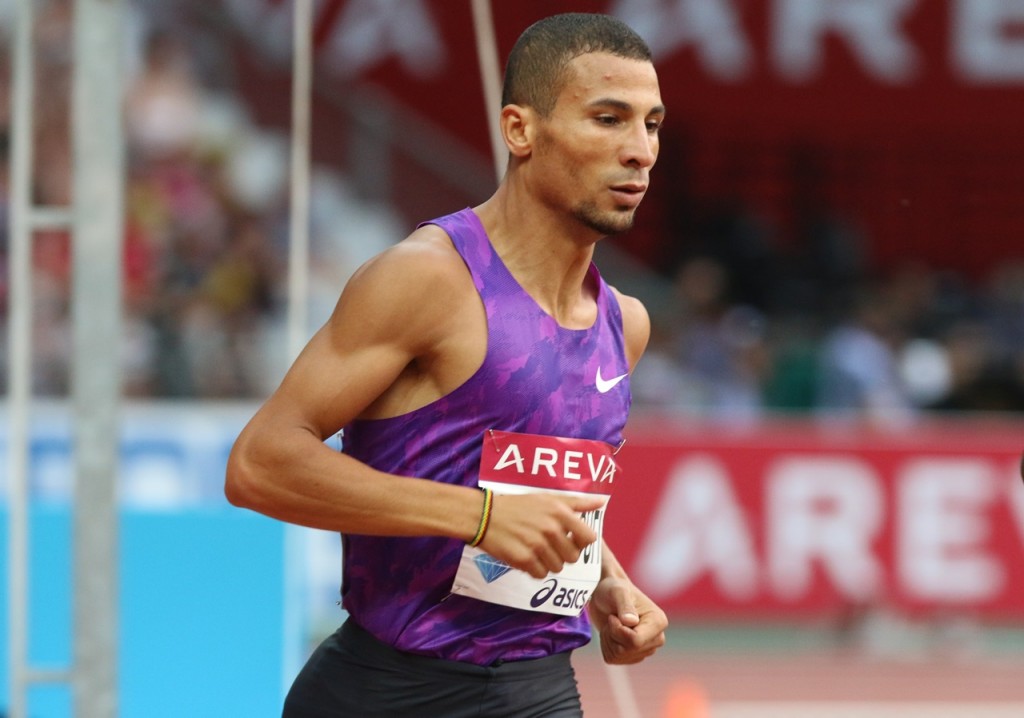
left=341, top=209, right=631, bottom=666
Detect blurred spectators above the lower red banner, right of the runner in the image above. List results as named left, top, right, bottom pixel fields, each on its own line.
left=634, top=206, right=1024, bottom=423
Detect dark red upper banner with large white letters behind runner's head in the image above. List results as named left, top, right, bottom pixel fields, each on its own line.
left=223, top=0, right=1024, bottom=147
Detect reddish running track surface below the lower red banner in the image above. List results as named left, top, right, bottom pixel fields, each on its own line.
left=575, top=622, right=1024, bottom=718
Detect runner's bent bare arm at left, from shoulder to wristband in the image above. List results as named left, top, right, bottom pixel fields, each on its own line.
left=224, top=230, right=483, bottom=536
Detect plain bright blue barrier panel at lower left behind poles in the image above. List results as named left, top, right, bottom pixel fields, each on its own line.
left=0, top=507, right=289, bottom=718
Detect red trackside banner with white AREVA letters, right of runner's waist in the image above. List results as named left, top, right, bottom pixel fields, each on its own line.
left=606, top=422, right=1024, bottom=618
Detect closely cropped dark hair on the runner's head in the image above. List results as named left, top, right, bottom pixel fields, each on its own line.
left=502, top=12, right=652, bottom=117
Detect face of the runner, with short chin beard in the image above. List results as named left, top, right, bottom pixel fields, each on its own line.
left=532, top=52, right=665, bottom=236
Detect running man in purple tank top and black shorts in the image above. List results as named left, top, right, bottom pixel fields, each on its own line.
left=225, top=13, right=668, bottom=718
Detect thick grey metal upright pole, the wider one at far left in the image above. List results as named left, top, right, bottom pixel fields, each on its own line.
left=71, top=0, right=125, bottom=718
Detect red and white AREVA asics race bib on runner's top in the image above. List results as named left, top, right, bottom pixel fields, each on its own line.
left=452, top=430, right=618, bottom=616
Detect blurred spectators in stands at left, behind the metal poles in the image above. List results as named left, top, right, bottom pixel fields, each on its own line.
left=0, top=0, right=391, bottom=398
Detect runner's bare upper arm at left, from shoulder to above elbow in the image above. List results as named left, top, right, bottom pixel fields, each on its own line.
left=251, top=229, right=482, bottom=438
